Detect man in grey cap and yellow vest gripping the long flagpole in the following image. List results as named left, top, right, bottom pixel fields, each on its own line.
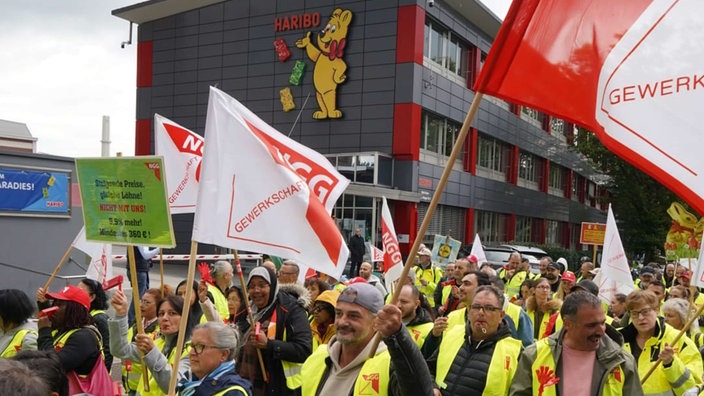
left=301, top=283, right=433, bottom=396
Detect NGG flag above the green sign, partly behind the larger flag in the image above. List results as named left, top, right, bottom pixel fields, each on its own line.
left=154, top=114, right=204, bottom=214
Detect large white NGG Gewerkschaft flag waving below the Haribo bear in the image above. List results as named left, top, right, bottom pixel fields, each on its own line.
left=193, top=87, right=349, bottom=279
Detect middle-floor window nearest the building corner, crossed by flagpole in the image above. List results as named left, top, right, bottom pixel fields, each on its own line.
left=420, top=112, right=464, bottom=167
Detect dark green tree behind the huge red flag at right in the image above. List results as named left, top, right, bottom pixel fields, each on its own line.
left=575, top=128, right=686, bottom=262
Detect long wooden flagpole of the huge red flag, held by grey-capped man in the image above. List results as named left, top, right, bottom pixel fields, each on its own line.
left=369, top=92, right=484, bottom=358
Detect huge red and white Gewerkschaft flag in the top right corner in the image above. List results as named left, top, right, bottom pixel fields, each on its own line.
left=475, top=0, right=704, bottom=213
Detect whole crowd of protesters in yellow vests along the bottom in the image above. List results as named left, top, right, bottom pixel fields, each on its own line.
left=6, top=251, right=704, bottom=396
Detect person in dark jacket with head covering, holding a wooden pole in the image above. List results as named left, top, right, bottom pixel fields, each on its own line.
left=237, top=267, right=313, bottom=396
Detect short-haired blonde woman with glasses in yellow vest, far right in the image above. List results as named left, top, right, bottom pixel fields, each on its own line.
left=619, top=290, right=703, bottom=395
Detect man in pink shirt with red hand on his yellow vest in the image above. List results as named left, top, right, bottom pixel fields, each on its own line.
left=510, top=291, right=643, bottom=396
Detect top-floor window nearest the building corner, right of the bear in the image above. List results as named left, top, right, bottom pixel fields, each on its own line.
left=423, top=20, right=468, bottom=79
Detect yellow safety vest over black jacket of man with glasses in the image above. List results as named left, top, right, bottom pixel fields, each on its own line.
left=435, top=326, right=522, bottom=396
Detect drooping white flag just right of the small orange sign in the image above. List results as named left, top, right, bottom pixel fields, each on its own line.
left=595, top=205, right=635, bottom=302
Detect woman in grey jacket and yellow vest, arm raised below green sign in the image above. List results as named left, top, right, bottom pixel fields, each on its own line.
left=108, top=291, right=192, bottom=396
